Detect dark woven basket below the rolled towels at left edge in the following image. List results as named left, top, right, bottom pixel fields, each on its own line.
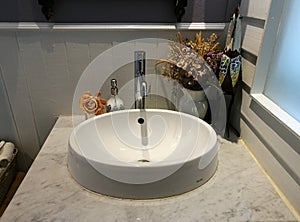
left=0, top=148, right=18, bottom=204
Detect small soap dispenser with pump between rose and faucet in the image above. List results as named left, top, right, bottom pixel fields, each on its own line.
left=106, top=79, right=125, bottom=113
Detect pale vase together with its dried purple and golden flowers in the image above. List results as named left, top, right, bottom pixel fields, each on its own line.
left=156, top=32, right=223, bottom=118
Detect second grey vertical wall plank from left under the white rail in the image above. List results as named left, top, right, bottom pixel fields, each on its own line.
left=18, top=32, right=55, bottom=144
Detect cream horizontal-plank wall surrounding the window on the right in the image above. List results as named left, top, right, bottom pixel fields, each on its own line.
left=240, top=0, right=300, bottom=213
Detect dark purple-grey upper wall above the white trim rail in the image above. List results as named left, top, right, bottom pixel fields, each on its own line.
left=0, top=0, right=240, bottom=23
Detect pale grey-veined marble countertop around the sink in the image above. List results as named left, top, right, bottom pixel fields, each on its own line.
left=1, top=117, right=296, bottom=222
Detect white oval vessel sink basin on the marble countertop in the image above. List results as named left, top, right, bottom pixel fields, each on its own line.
left=68, top=109, right=219, bottom=199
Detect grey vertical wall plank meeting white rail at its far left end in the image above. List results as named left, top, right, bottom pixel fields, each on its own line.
left=0, top=32, right=40, bottom=159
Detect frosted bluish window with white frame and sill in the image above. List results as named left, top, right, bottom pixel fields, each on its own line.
left=251, top=0, right=300, bottom=135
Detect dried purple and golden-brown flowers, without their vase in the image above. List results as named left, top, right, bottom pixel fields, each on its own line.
left=156, top=32, right=223, bottom=90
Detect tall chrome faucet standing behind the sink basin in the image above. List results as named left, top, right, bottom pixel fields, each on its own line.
left=134, top=51, right=147, bottom=109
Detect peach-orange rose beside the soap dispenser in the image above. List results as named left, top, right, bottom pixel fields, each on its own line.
left=79, top=91, right=106, bottom=115
